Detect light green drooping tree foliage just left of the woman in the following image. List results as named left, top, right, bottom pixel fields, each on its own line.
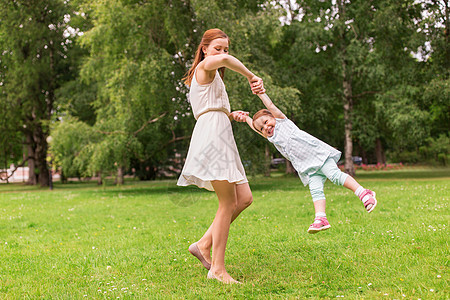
left=51, top=1, right=195, bottom=183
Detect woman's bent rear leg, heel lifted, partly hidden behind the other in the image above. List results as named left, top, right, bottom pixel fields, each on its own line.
left=197, top=183, right=253, bottom=263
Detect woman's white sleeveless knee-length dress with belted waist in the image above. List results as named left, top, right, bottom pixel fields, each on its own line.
left=177, top=71, right=248, bottom=191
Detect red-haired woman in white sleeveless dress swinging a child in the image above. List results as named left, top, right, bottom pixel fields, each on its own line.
left=177, top=29, right=265, bottom=283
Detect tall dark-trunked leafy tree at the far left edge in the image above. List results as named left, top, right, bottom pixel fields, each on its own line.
left=0, top=0, right=78, bottom=186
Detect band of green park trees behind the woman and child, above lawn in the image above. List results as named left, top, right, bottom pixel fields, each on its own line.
left=0, top=0, right=450, bottom=186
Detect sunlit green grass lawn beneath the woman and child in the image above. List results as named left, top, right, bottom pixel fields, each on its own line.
left=0, top=169, right=450, bottom=299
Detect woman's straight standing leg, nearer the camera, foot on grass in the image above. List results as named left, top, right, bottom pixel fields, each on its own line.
left=208, top=181, right=241, bottom=283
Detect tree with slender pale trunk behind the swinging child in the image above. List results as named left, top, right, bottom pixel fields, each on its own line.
left=279, top=0, right=436, bottom=174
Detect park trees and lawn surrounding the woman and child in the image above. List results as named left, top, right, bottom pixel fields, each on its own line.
left=0, top=0, right=450, bottom=299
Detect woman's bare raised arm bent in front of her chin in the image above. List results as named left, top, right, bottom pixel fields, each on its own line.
left=199, top=54, right=266, bottom=94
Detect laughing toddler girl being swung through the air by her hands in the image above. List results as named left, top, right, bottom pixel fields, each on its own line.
left=235, top=94, right=377, bottom=233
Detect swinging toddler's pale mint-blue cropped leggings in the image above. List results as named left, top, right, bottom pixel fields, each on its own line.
left=308, top=158, right=349, bottom=202
